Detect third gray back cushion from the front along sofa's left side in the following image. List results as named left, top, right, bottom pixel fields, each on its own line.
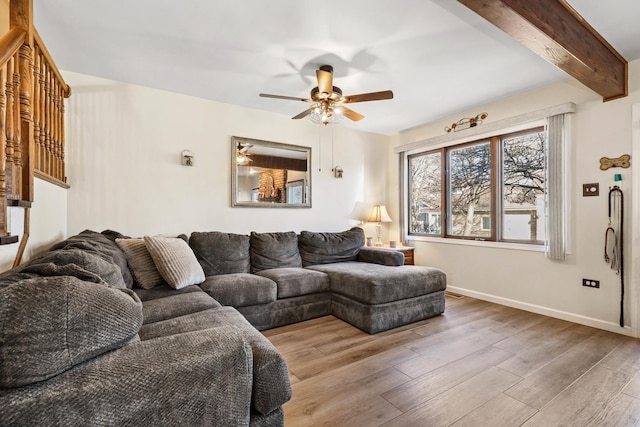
left=51, top=230, right=133, bottom=289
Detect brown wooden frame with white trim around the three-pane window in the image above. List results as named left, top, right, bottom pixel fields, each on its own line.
left=405, top=122, right=547, bottom=246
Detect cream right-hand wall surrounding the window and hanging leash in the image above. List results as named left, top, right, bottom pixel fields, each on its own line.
left=389, top=61, right=640, bottom=333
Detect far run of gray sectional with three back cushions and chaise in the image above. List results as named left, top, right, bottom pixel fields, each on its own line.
left=189, top=227, right=446, bottom=334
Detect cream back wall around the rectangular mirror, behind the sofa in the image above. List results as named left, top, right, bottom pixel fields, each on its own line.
left=63, top=72, right=389, bottom=241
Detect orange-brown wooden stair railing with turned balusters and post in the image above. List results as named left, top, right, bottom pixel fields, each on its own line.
left=0, top=0, right=71, bottom=264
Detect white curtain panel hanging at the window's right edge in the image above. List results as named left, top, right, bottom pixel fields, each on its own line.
left=545, top=114, right=567, bottom=260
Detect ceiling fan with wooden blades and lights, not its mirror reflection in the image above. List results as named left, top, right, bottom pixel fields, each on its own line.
left=260, top=65, right=393, bottom=125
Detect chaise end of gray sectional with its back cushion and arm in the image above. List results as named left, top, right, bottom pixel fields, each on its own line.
left=299, top=227, right=446, bottom=334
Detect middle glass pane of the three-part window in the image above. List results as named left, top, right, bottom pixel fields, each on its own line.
left=448, top=142, right=492, bottom=237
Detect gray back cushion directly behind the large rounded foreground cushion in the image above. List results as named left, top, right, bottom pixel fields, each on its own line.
left=21, top=247, right=127, bottom=289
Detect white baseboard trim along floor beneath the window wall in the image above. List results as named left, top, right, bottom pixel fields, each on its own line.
left=445, top=286, right=633, bottom=336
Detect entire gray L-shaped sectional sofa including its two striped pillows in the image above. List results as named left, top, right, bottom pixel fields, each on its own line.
left=0, top=228, right=446, bottom=426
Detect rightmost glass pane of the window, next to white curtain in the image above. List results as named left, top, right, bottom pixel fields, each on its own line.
left=502, top=130, right=545, bottom=241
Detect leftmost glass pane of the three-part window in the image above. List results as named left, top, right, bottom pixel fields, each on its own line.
left=409, top=152, right=442, bottom=234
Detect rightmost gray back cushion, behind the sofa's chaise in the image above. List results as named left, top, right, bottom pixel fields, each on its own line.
left=298, top=227, right=364, bottom=267
